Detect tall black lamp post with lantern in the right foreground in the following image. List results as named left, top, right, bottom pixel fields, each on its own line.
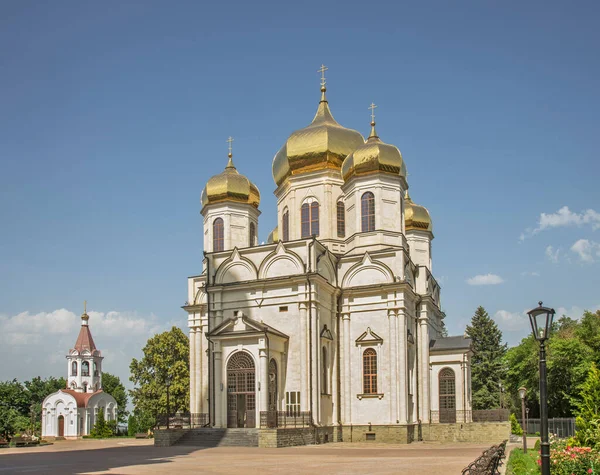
left=527, top=302, right=555, bottom=475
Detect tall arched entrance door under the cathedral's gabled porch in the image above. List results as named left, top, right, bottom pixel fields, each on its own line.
left=227, top=351, right=256, bottom=427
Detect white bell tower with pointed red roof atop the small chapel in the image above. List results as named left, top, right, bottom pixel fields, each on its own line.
left=67, top=302, right=103, bottom=393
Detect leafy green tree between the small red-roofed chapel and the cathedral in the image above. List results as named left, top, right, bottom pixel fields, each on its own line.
left=129, top=327, right=190, bottom=419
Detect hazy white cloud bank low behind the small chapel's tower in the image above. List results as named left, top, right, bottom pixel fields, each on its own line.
left=0, top=308, right=185, bottom=387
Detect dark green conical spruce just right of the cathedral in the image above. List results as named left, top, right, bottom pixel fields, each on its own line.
left=467, top=306, right=507, bottom=409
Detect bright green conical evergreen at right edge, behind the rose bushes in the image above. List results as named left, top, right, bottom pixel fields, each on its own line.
left=573, top=363, right=600, bottom=448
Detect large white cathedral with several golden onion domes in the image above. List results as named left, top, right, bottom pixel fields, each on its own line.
left=184, top=72, right=471, bottom=440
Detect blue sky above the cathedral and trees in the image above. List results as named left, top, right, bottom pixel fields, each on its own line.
left=0, top=1, right=600, bottom=379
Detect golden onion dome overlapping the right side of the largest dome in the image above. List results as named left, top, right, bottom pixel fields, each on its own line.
left=342, top=121, right=406, bottom=181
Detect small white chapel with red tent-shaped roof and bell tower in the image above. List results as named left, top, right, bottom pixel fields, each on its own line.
left=42, top=311, right=117, bottom=439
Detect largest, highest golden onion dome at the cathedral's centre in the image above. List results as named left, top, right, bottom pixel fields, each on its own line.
left=273, top=85, right=364, bottom=186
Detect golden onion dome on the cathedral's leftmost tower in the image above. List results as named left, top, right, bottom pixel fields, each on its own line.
left=201, top=153, right=260, bottom=208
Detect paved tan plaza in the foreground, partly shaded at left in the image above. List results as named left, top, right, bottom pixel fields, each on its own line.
left=0, top=439, right=489, bottom=475
